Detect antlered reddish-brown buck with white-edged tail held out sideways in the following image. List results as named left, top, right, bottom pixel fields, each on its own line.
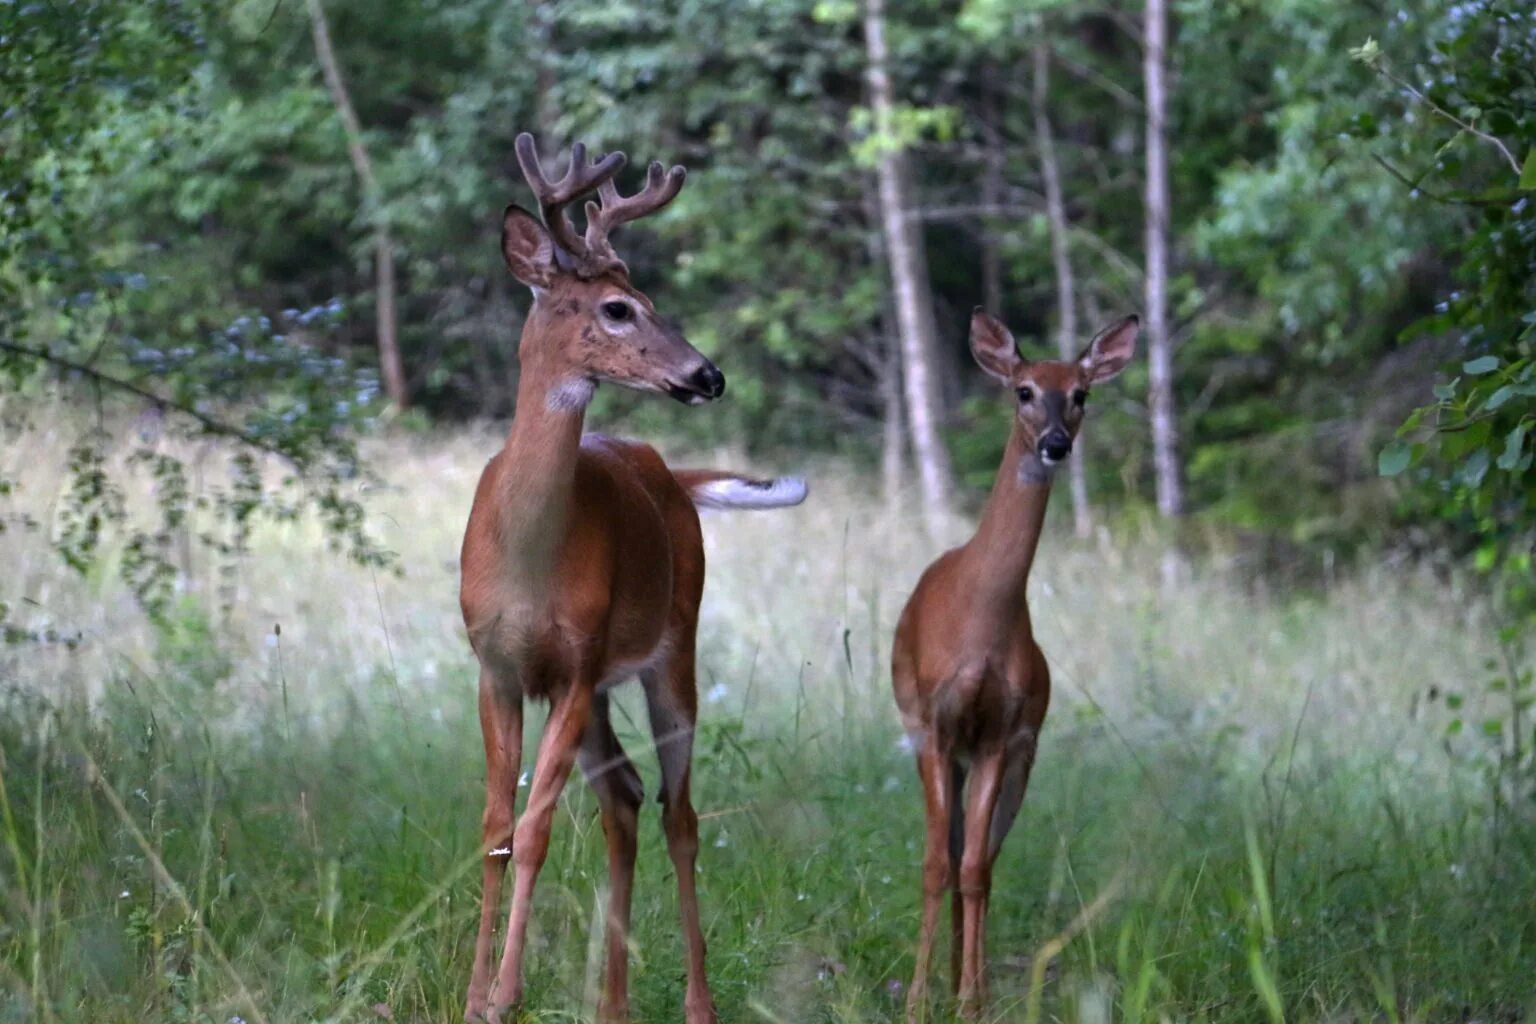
left=459, top=134, right=806, bottom=1024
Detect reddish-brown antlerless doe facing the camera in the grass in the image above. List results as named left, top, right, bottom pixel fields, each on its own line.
left=891, top=309, right=1140, bottom=1022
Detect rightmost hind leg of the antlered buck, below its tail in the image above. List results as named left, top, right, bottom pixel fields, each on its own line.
left=641, top=657, right=719, bottom=1024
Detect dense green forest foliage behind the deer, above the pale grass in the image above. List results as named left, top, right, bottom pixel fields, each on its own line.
left=0, top=0, right=1533, bottom=568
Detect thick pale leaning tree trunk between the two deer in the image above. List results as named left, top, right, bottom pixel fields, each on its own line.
left=865, top=0, right=951, bottom=530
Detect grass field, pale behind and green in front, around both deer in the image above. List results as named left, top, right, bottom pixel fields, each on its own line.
left=0, top=417, right=1536, bottom=1024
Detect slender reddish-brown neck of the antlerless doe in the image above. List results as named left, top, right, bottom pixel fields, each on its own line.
left=965, top=421, right=1052, bottom=606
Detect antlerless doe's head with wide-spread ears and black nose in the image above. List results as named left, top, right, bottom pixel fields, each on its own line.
left=971, top=307, right=1141, bottom=467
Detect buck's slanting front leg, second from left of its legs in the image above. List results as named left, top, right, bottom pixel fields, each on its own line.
left=492, top=680, right=593, bottom=1019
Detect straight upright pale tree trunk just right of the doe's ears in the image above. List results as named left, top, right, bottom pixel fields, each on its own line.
left=1143, top=0, right=1184, bottom=517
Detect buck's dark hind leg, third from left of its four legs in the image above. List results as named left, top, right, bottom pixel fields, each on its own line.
left=578, top=694, right=645, bottom=1024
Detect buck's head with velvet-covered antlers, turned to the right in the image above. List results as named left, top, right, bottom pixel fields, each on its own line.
left=501, top=134, right=725, bottom=408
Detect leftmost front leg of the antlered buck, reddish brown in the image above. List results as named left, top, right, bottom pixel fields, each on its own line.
left=464, top=668, right=522, bottom=1021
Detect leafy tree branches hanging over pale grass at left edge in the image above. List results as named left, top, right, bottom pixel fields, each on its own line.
left=0, top=0, right=392, bottom=626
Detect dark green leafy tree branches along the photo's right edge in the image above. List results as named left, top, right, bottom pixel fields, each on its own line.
left=1353, top=0, right=1536, bottom=792
